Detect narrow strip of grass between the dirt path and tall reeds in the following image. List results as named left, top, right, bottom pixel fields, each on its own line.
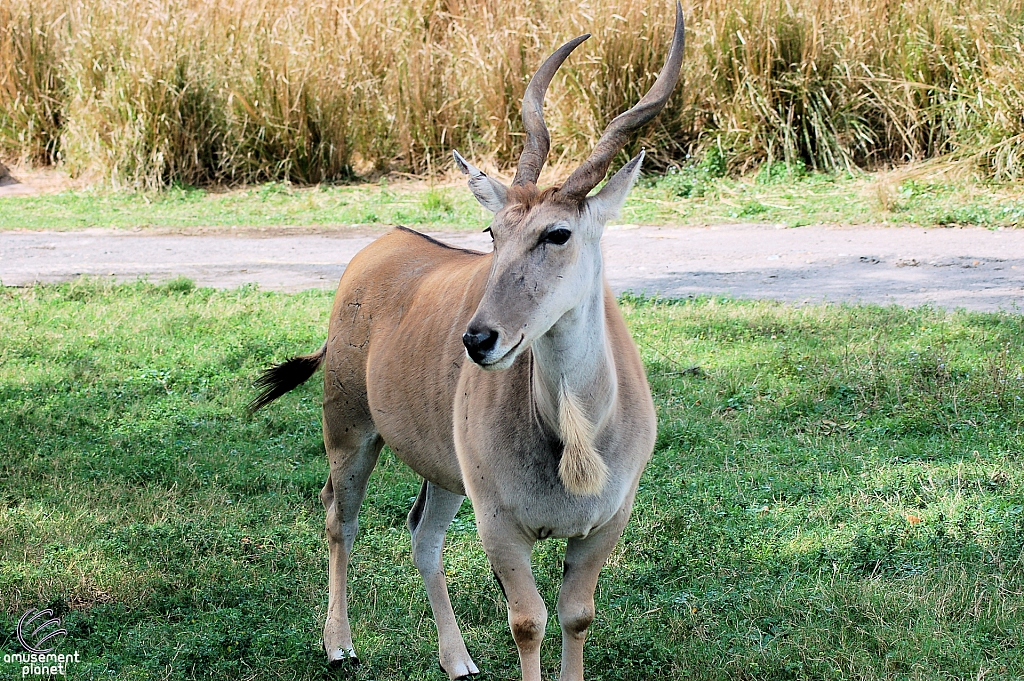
left=0, top=168, right=1024, bottom=230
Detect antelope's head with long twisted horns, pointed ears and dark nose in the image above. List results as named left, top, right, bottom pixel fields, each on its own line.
left=455, top=2, right=683, bottom=370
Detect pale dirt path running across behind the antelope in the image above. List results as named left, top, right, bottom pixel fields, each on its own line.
left=0, top=224, right=1024, bottom=311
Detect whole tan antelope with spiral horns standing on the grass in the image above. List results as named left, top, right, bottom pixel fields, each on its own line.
left=251, top=3, right=683, bottom=681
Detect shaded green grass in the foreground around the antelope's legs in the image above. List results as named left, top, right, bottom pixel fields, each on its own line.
left=0, top=281, right=1024, bottom=681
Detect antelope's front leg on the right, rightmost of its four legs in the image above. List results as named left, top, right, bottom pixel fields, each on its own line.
left=558, top=495, right=633, bottom=681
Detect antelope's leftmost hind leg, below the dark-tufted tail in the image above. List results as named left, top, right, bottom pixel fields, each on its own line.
left=321, top=426, right=383, bottom=666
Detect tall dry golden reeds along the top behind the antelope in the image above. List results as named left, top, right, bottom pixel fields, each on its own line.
left=0, top=0, right=1024, bottom=186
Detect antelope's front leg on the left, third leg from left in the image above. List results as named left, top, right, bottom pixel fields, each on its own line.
left=477, top=510, right=548, bottom=681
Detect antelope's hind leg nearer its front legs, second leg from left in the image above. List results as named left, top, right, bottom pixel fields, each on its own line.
left=409, top=480, right=479, bottom=679
